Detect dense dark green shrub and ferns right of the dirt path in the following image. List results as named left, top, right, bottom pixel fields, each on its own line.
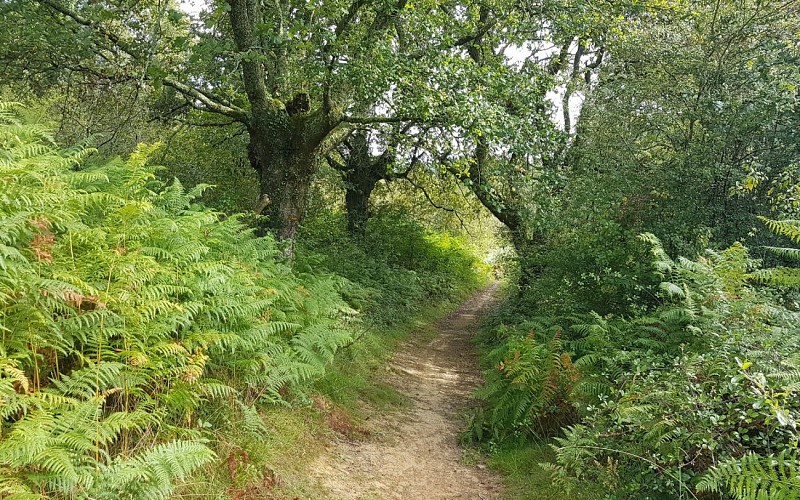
left=472, top=230, right=800, bottom=498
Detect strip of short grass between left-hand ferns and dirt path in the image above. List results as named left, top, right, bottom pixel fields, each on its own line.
left=179, top=283, right=477, bottom=500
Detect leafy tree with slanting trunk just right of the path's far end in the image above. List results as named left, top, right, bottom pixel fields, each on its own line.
left=410, top=2, right=619, bottom=287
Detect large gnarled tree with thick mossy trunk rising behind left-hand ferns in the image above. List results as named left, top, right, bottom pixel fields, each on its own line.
left=10, top=0, right=406, bottom=239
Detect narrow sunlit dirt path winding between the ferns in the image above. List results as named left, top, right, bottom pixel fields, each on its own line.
left=314, top=284, right=500, bottom=500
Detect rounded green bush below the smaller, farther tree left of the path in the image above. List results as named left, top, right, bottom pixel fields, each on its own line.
left=299, top=206, right=486, bottom=325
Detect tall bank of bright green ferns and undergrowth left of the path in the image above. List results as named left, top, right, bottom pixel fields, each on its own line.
left=0, top=103, right=484, bottom=498
